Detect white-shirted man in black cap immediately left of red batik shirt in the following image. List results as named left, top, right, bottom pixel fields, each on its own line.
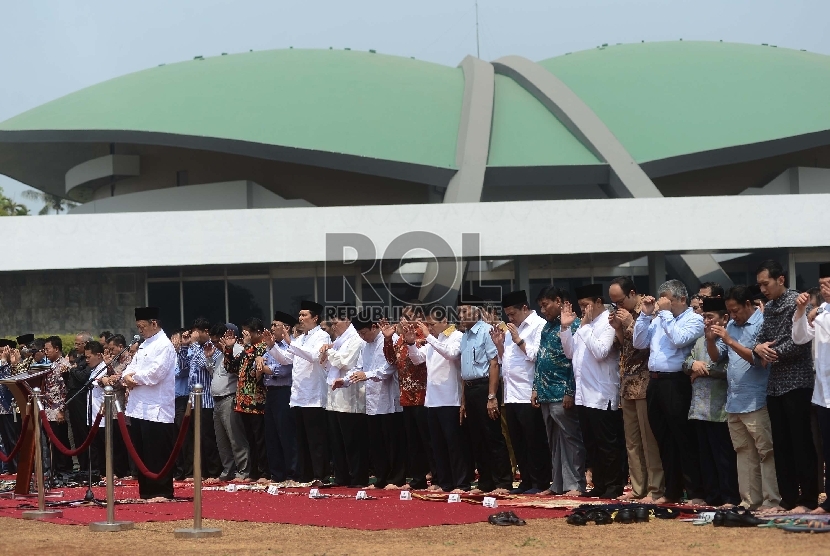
left=338, top=314, right=408, bottom=490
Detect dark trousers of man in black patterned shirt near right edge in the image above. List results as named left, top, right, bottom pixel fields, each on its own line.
left=767, top=388, right=818, bottom=510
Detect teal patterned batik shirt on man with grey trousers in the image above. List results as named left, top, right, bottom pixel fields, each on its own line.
left=533, top=317, right=579, bottom=403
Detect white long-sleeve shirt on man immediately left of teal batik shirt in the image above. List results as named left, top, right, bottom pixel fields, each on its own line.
left=501, top=311, right=547, bottom=403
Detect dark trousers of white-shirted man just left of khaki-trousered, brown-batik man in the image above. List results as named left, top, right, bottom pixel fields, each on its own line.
left=577, top=404, right=628, bottom=498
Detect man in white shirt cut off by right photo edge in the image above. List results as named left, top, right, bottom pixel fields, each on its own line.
left=792, top=263, right=830, bottom=514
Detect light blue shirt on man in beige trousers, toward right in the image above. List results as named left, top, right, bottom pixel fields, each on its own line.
left=717, top=309, right=769, bottom=413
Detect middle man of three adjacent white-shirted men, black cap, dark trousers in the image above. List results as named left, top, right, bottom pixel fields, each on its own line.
left=320, top=308, right=369, bottom=487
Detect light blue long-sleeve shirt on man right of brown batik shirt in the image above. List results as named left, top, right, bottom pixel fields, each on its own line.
left=633, top=307, right=703, bottom=373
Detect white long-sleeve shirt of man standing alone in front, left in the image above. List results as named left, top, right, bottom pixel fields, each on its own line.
left=123, top=330, right=177, bottom=423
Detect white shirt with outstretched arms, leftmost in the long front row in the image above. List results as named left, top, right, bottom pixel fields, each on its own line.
left=276, top=326, right=330, bottom=408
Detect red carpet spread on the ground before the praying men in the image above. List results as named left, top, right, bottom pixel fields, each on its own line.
left=0, top=481, right=568, bottom=530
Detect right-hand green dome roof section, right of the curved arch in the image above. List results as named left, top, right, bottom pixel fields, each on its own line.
left=539, top=41, right=830, bottom=163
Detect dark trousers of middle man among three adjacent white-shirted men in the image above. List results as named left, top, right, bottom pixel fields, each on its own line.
left=327, top=411, right=369, bottom=487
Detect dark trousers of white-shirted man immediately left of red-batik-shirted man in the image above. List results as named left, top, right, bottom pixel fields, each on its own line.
left=366, top=412, right=406, bottom=488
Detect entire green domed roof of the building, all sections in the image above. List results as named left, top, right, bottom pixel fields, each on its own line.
left=0, top=41, right=830, bottom=181
